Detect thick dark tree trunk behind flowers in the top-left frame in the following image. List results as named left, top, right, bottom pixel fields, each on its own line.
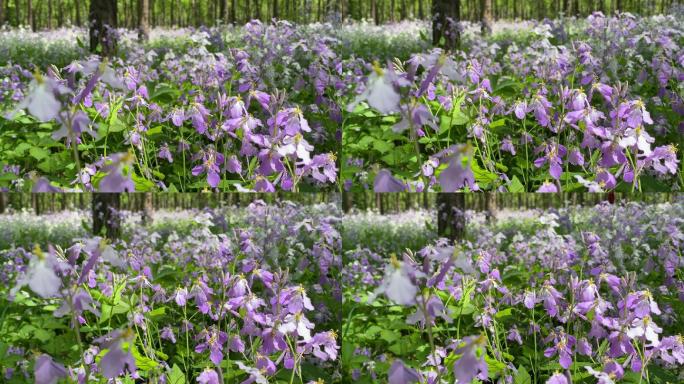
left=88, top=0, right=117, bottom=57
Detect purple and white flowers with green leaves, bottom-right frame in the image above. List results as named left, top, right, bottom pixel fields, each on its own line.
left=342, top=199, right=684, bottom=384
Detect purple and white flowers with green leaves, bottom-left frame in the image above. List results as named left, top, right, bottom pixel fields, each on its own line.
left=0, top=201, right=341, bottom=384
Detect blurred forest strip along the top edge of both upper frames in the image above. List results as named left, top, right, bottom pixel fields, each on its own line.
left=0, top=0, right=681, bottom=30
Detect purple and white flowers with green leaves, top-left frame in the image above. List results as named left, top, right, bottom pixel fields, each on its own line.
left=0, top=21, right=353, bottom=192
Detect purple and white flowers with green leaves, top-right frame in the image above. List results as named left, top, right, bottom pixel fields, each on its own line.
left=341, top=12, right=684, bottom=192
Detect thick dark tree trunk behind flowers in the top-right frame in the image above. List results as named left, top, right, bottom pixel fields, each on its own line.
left=432, top=0, right=461, bottom=51
